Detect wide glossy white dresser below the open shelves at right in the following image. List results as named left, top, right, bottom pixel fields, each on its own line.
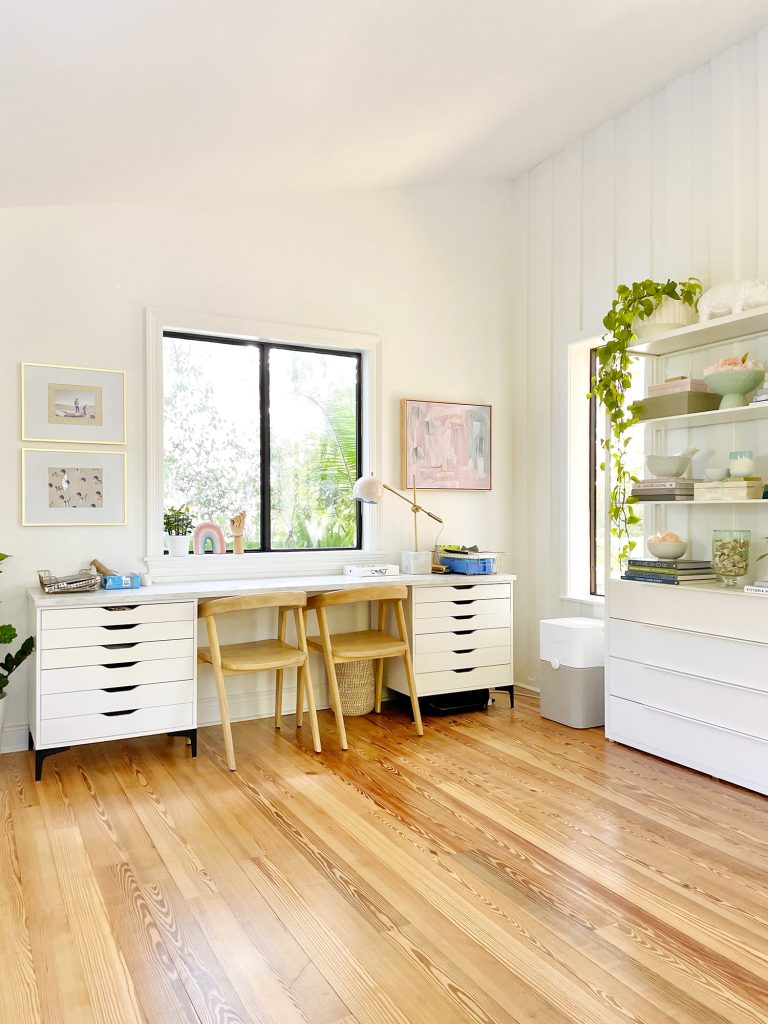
left=605, top=581, right=768, bottom=794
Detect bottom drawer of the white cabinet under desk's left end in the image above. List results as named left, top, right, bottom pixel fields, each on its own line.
left=37, top=703, right=195, bottom=746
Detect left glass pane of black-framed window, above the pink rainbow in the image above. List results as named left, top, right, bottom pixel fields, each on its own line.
left=163, top=338, right=260, bottom=549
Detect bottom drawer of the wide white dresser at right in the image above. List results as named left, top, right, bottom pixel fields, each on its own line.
left=608, top=697, right=768, bottom=794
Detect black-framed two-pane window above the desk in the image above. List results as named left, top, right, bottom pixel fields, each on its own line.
left=163, top=332, right=362, bottom=552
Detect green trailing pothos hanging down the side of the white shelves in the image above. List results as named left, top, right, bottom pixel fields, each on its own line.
left=589, top=278, right=701, bottom=562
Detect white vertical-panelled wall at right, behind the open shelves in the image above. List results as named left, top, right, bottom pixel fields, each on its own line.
left=511, top=29, right=768, bottom=683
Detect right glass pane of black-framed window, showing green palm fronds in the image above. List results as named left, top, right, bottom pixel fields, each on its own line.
left=269, top=348, right=359, bottom=548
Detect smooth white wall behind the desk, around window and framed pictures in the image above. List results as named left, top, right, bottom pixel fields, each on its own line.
left=0, top=184, right=513, bottom=750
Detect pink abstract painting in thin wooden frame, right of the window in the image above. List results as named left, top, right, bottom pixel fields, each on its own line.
left=400, top=398, right=490, bottom=490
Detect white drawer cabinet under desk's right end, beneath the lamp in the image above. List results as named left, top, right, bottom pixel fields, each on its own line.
left=386, top=575, right=514, bottom=697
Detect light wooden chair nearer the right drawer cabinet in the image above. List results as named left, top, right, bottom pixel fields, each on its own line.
left=307, top=584, right=424, bottom=751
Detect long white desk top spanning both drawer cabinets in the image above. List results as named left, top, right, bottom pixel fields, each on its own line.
left=28, top=572, right=517, bottom=608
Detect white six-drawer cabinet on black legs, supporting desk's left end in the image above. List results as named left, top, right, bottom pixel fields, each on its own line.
left=30, top=595, right=197, bottom=780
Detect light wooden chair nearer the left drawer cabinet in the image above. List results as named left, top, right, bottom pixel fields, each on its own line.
left=198, top=591, right=321, bottom=771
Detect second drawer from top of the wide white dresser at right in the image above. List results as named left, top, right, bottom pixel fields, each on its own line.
left=608, top=618, right=768, bottom=690
